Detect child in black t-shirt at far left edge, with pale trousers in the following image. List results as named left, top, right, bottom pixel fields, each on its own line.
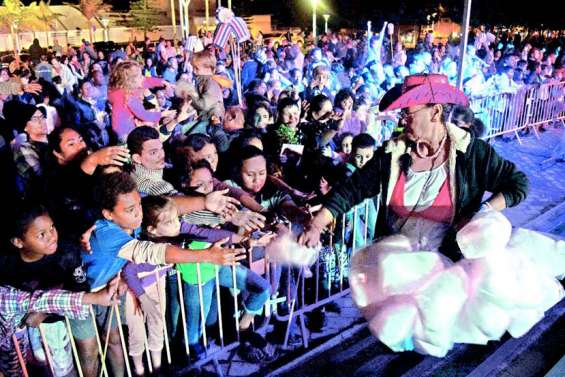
left=0, top=203, right=88, bottom=376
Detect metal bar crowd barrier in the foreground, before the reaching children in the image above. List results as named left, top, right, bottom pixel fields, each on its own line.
left=19, top=200, right=369, bottom=377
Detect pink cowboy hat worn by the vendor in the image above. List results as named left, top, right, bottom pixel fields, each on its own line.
left=379, top=73, right=469, bottom=111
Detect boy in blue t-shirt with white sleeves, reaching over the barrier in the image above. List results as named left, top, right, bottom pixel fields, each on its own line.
left=73, top=172, right=244, bottom=375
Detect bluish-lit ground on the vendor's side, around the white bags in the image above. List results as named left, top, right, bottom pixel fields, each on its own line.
left=191, top=128, right=565, bottom=377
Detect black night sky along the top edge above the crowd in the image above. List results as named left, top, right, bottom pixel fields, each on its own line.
left=34, top=0, right=565, bottom=29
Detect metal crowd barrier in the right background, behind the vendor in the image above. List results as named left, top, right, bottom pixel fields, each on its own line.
left=470, top=82, right=565, bottom=143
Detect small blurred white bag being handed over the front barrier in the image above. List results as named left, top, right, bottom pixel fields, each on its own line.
left=265, top=233, right=319, bottom=267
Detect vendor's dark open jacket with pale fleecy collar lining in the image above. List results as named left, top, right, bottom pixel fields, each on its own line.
left=325, top=123, right=528, bottom=259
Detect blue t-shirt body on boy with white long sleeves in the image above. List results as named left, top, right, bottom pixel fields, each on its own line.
left=82, top=220, right=141, bottom=289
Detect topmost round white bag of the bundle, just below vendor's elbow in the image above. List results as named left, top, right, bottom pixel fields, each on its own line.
left=456, top=210, right=512, bottom=258
